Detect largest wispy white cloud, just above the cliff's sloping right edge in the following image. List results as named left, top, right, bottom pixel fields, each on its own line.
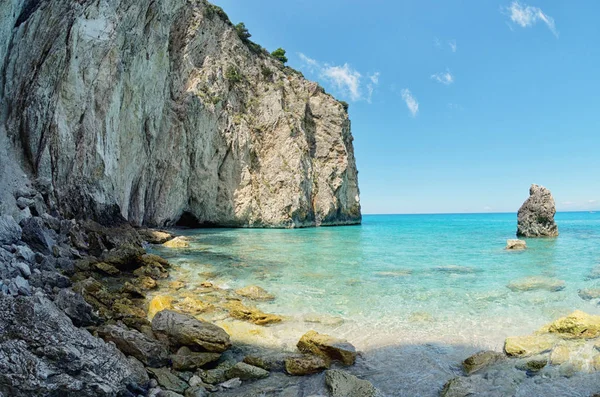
left=298, top=52, right=379, bottom=103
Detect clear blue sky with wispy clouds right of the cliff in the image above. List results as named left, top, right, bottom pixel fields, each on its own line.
left=214, top=0, right=600, bottom=214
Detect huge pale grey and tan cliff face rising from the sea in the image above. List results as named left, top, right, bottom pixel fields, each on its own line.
left=0, top=0, right=361, bottom=227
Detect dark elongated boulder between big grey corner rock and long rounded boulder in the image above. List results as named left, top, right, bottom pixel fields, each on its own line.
left=98, top=325, right=169, bottom=367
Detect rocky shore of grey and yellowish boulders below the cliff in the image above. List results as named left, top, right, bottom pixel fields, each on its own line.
left=0, top=181, right=376, bottom=397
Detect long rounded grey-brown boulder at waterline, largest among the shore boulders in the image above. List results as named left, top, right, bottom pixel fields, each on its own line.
left=152, top=310, right=231, bottom=353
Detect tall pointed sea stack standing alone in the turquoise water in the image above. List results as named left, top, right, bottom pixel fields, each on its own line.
left=517, top=184, right=558, bottom=237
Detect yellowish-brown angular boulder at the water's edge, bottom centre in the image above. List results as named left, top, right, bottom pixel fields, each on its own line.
left=296, top=331, right=356, bottom=365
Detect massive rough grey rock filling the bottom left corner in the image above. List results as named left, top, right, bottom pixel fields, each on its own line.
left=0, top=296, right=139, bottom=397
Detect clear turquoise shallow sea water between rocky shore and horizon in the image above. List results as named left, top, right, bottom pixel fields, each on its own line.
left=152, top=212, right=600, bottom=395
